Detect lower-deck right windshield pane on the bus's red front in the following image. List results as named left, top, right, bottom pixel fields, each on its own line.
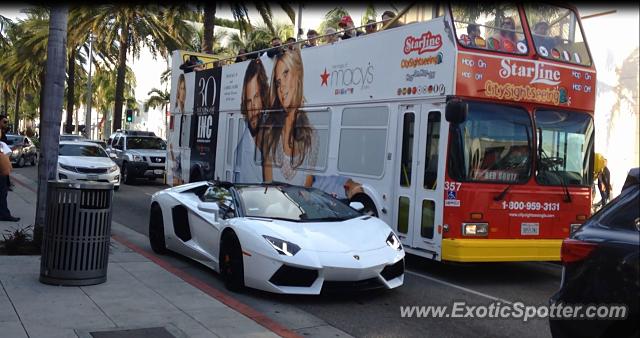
left=535, top=110, right=593, bottom=186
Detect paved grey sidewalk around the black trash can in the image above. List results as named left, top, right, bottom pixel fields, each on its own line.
left=0, top=174, right=288, bottom=338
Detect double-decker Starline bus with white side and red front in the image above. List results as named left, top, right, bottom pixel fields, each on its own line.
left=167, top=4, right=596, bottom=262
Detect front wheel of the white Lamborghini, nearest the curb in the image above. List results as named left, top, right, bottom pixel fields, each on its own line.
left=220, top=232, right=244, bottom=292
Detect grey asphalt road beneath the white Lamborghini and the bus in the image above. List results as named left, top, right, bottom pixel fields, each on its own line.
left=15, top=167, right=561, bottom=338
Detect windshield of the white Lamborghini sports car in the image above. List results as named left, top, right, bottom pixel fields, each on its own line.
left=238, top=186, right=362, bottom=222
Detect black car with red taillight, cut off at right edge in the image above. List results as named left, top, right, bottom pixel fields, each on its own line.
left=549, top=168, right=640, bottom=337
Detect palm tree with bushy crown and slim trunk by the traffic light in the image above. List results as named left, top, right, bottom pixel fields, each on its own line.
left=86, top=4, right=193, bottom=130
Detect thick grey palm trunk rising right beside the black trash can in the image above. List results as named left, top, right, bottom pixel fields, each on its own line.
left=34, top=5, right=69, bottom=245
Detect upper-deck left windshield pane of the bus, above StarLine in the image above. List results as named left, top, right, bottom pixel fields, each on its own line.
left=451, top=3, right=528, bottom=54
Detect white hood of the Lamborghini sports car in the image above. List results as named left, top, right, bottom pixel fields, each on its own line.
left=240, top=216, right=391, bottom=252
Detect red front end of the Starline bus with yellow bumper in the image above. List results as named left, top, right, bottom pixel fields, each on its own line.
left=441, top=4, right=596, bottom=262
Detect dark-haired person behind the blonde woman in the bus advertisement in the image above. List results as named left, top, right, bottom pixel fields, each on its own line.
left=234, top=59, right=269, bottom=183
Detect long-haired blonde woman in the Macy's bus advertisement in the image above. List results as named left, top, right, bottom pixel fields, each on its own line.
left=259, top=49, right=319, bottom=185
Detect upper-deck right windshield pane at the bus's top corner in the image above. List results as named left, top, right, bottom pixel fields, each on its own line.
left=524, top=3, right=591, bottom=66
